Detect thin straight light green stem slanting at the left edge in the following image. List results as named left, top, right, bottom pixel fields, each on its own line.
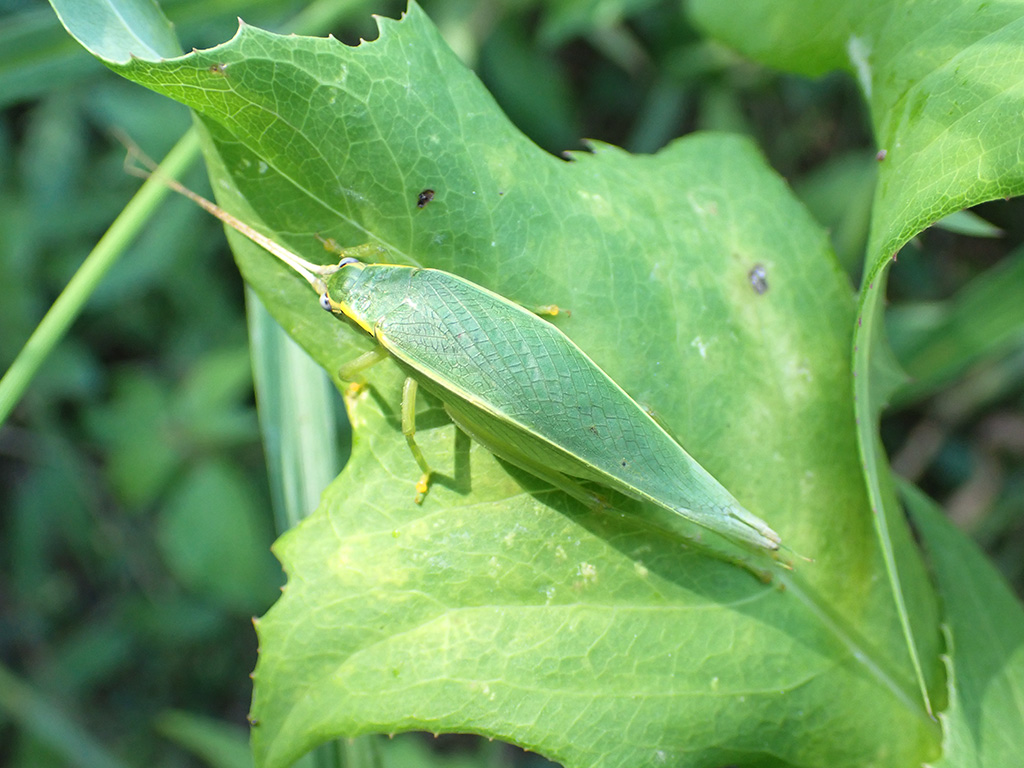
left=0, top=130, right=199, bottom=425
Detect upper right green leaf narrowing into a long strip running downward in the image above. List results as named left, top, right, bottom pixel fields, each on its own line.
left=690, top=0, right=1024, bottom=729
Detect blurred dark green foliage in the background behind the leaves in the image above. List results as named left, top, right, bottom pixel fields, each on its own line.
left=0, top=0, right=1024, bottom=766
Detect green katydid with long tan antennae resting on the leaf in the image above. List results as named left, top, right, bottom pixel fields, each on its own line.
left=146, top=169, right=780, bottom=551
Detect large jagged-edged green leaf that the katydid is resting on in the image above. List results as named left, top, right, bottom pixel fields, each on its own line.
left=51, top=5, right=938, bottom=766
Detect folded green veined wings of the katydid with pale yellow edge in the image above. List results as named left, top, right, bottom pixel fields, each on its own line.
left=374, top=269, right=778, bottom=549
